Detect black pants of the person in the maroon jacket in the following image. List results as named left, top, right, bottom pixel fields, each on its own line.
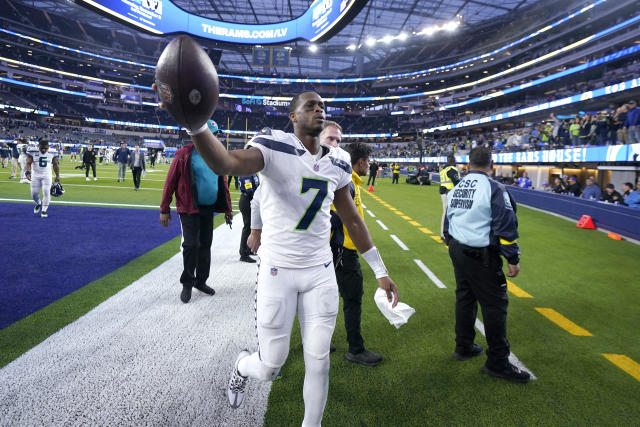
left=180, top=206, right=213, bottom=287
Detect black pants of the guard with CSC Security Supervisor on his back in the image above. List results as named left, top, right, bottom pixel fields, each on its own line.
left=449, top=239, right=510, bottom=369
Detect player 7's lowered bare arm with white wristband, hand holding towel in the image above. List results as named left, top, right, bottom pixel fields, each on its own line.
left=333, top=186, right=398, bottom=307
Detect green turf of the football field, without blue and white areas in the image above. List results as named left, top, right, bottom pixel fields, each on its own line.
left=0, top=165, right=640, bottom=426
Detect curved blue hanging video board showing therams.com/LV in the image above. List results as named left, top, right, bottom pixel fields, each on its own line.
left=78, top=0, right=366, bottom=44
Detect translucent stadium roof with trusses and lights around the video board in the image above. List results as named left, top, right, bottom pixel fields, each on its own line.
left=15, top=0, right=544, bottom=77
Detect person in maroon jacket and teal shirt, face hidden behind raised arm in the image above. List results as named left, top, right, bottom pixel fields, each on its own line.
left=160, top=144, right=233, bottom=304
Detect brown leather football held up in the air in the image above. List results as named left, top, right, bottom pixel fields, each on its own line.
left=155, top=35, right=219, bottom=130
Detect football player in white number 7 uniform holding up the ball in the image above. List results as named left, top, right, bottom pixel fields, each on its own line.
left=172, top=92, right=398, bottom=426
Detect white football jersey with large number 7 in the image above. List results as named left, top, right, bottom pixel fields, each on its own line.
left=248, top=128, right=351, bottom=268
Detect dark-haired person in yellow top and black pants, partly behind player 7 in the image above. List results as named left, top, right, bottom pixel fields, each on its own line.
left=325, top=142, right=382, bottom=366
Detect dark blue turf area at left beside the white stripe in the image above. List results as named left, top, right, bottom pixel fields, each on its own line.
left=0, top=203, right=180, bottom=329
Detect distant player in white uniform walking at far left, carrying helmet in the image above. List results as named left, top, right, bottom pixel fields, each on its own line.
left=25, top=138, right=60, bottom=218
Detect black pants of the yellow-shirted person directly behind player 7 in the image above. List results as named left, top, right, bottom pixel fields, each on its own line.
left=332, top=247, right=364, bottom=354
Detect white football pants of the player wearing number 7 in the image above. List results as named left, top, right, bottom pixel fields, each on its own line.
left=238, top=262, right=339, bottom=427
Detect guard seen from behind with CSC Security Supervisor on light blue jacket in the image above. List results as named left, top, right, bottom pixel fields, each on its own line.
left=444, top=147, right=530, bottom=383
